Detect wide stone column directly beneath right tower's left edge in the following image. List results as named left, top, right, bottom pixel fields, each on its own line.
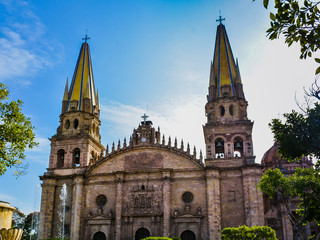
left=206, top=169, right=221, bottom=240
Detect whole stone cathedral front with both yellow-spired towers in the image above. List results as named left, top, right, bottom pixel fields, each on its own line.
left=39, top=20, right=265, bottom=240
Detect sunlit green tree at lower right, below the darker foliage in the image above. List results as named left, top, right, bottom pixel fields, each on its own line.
left=258, top=168, right=320, bottom=239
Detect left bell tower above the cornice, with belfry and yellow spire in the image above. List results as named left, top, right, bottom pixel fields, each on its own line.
left=49, top=35, right=104, bottom=169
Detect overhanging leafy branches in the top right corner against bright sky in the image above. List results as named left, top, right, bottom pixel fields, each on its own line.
left=253, top=0, right=320, bottom=73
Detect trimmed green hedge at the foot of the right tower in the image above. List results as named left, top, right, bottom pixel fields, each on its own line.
left=221, top=225, right=277, bottom=240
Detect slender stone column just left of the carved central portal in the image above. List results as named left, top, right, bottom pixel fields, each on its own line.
left=115, top=173, right=123, bottom=240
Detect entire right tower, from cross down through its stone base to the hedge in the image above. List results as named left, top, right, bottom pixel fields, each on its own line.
left=203, top=16, right=264, bottom=236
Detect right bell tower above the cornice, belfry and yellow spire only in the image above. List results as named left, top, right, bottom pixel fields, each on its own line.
left=203, top=16, right=255, bottom=166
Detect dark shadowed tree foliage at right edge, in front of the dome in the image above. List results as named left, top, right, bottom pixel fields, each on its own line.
left=269, top=103, right=320, bottom=160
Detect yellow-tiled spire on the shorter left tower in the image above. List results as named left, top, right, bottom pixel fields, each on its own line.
left=67, top=40, right=96, bottom=114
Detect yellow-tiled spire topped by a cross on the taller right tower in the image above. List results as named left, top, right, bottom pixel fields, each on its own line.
left=209, top=19, right=244, bottom=99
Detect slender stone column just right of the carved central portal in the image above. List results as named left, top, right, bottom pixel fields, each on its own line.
left=162, top=171, right=171, bottom=237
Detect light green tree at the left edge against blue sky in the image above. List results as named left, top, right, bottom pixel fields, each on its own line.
left=0, top=83, right=37, bottom=176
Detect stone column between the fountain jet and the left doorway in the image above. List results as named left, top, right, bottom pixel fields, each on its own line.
left=70, top=176, right=83, bottom=240
